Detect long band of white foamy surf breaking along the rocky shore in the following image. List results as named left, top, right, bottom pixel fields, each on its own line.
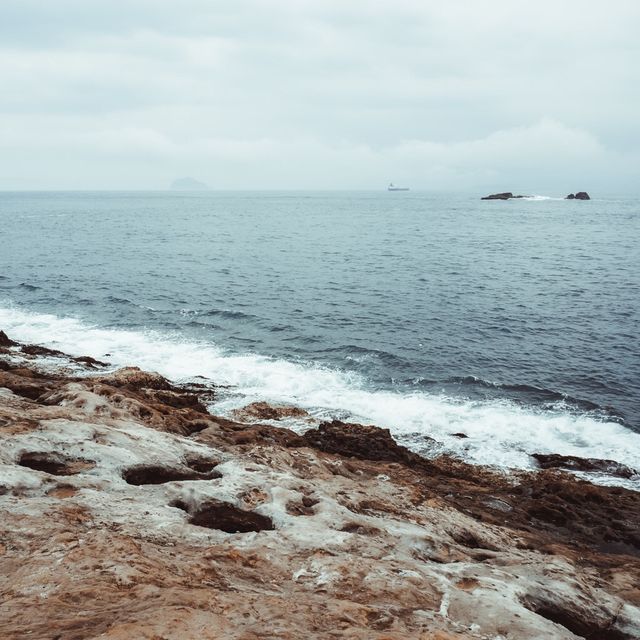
left=0, top=306, right=640, bottom=489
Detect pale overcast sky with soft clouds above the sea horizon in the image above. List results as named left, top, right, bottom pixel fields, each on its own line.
left=0, top=0, right=640, bottom=195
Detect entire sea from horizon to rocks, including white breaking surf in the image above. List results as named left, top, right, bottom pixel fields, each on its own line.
left=0, top=192, right=640, bottom=484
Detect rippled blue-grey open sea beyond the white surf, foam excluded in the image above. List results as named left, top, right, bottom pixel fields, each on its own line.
left=0, top=192, right=640, bottom=428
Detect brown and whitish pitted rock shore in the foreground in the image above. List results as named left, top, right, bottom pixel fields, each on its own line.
left=0, top=332, right=640, bottom=640
